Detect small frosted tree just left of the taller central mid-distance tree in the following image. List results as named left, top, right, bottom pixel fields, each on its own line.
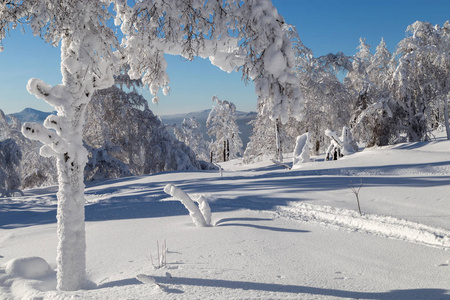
left=174, top=117, right=210, bottom=161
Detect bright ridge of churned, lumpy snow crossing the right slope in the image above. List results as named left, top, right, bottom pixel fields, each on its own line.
left=276, top=203, right=450, bottom=248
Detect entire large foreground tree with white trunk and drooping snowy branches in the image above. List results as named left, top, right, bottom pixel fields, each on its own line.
left=0, top=0, right=301, bottom=290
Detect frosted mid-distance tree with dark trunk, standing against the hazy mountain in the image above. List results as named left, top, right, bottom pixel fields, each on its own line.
left=206, top=96, right=242, bottom=161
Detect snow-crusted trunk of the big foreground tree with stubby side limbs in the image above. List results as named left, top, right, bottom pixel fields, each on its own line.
left=22, top=1, right=118, bottom=290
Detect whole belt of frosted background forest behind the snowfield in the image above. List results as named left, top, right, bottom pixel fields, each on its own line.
left=0, top=21, right=450, bottom=194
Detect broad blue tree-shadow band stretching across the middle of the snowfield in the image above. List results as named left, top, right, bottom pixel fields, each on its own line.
left=0, top=161, right=450, bottom=229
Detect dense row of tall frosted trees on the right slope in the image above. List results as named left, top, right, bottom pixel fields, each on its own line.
left=244, top=21, right=450, bottom=162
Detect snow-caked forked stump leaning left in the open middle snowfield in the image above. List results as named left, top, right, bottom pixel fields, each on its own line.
left=164, top=183, right=211, bottom=227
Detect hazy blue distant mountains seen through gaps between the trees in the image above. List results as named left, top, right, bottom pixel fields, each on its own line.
left=7, top=108, right=256, bottom=148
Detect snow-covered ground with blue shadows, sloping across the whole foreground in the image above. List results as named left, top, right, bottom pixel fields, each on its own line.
left=0, top=140, right=450, bottom=299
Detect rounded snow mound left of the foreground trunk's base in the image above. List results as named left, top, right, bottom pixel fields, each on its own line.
left=5, top=257, right=53, bottom=279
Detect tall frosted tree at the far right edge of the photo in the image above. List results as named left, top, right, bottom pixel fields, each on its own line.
left=393, top=21, right=450, bottom=141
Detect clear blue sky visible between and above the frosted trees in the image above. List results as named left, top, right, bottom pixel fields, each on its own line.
left=0, top=0, right=450, bottom=115
